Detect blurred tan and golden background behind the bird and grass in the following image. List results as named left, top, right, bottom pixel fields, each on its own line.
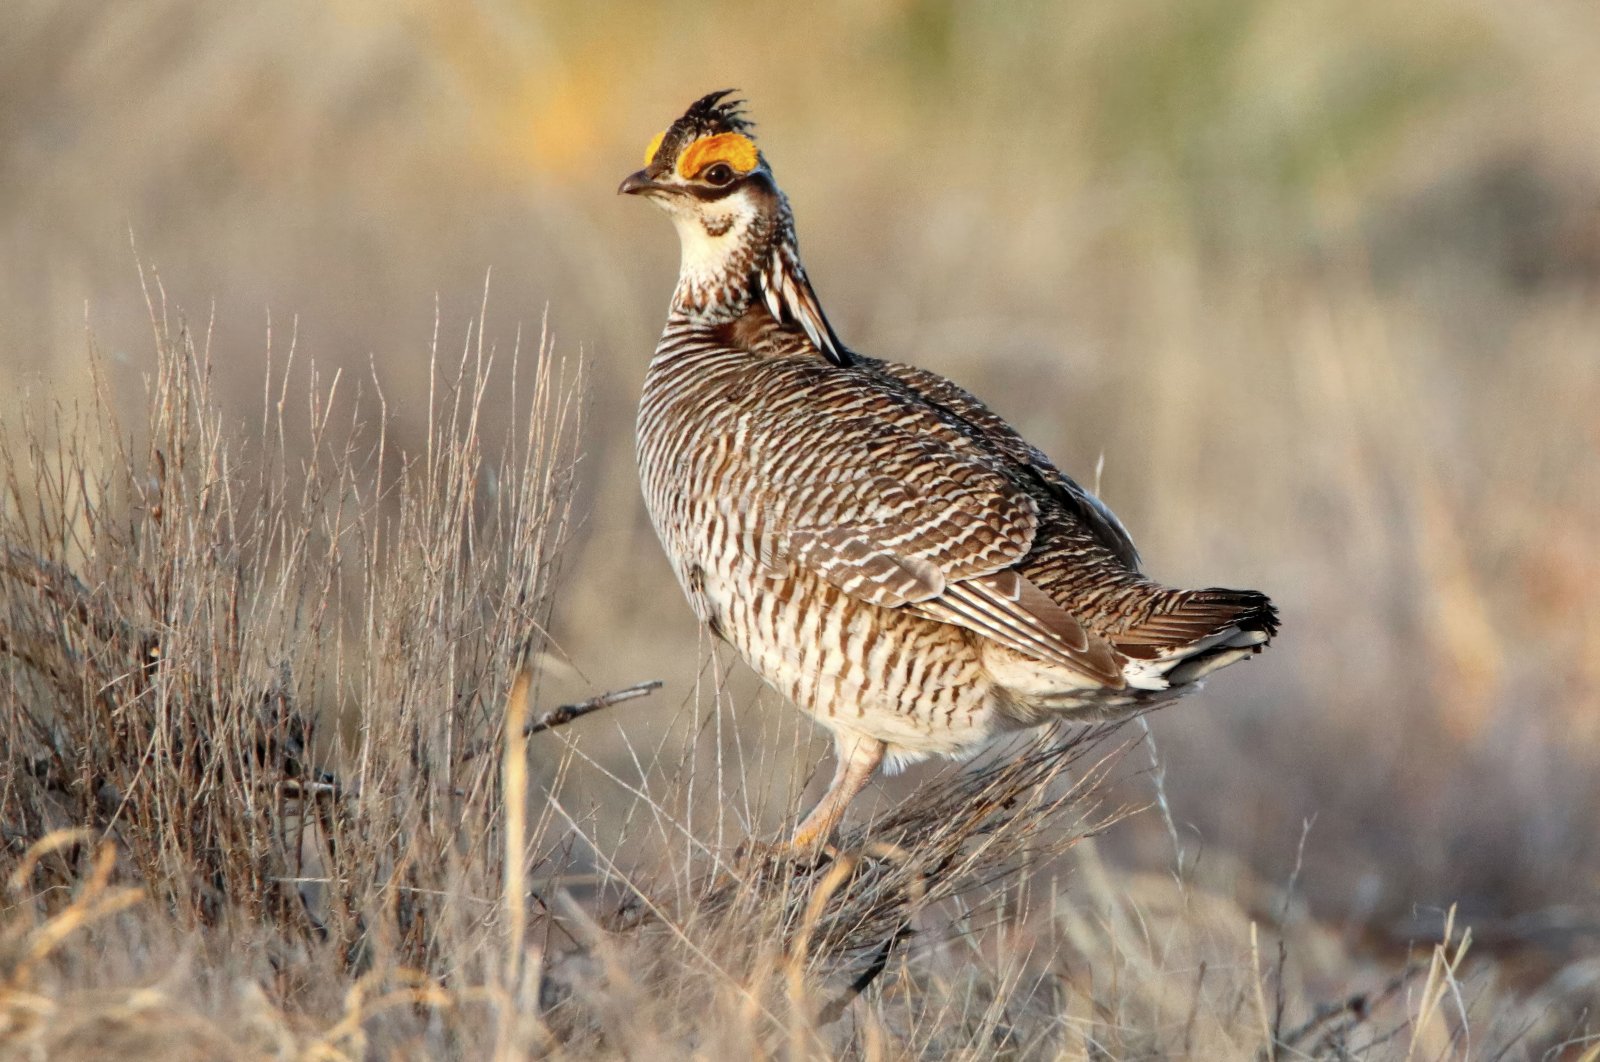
left=0, top=0, right=1600, bottom=956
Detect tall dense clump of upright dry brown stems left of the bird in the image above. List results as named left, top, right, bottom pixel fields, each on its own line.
left=0, top=286, right=576, bottom=1055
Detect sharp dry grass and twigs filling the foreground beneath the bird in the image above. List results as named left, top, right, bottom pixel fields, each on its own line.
left=0, top=294, right=1592, bottom=1059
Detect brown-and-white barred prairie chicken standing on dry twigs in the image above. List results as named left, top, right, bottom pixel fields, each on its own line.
left=618, top=90, right=1278, bottom=849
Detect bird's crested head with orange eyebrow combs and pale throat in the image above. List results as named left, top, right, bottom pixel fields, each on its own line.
left=618, top=90, right=789, bottom=308
